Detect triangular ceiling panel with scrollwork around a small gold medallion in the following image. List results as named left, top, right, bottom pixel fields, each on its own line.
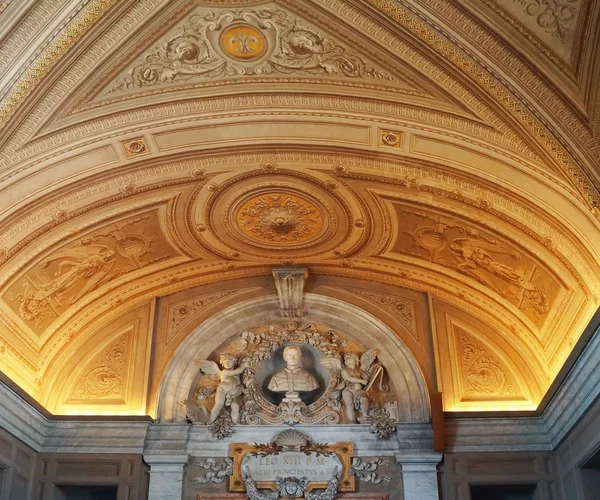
left=88, top=3, right=428, bottom=107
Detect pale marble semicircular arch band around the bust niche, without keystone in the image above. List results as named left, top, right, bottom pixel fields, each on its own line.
left=157, top=293, right=430, bottom=422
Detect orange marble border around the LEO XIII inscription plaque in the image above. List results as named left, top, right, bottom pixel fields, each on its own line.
left=227, top=442, right=356, bottom=492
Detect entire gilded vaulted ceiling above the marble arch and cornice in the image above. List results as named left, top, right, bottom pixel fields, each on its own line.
left=0, top=0, right=600, bottom=414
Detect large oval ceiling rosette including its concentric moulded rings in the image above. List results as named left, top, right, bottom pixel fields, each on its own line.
left=193, top=169, right=371, bottom=265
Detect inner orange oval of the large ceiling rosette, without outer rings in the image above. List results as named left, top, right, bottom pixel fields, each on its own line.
left=236, top=193, right=323, bottom=244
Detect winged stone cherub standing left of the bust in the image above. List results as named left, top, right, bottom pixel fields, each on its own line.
left=198, top=354, right=248, bottom=424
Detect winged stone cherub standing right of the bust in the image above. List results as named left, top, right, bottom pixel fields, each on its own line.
left=321, top=349, right=383, bottom=423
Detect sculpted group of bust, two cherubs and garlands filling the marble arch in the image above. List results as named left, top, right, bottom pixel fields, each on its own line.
left=182, top=321, right=398, bottom=438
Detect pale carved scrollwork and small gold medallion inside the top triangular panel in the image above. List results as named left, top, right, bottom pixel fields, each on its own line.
left=108, top=8, right=393, bottom=94
